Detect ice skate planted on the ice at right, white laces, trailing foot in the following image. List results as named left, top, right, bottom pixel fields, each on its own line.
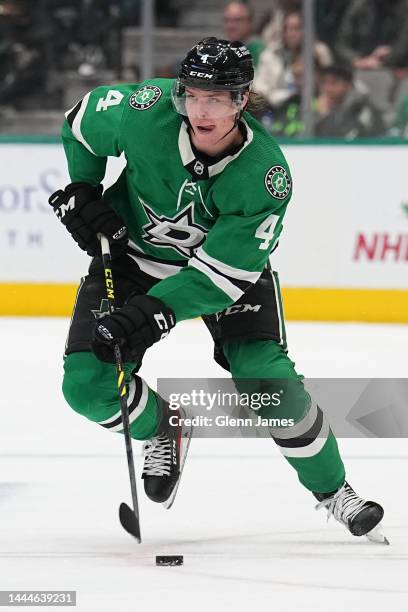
left=313, top=482, right=389, bottom=544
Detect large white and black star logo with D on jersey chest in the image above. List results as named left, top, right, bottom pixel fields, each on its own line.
left=139, top=198, right=207, bottom=258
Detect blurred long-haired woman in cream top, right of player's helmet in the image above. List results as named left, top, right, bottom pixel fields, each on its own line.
left=254, top=11, right=332, bottom=107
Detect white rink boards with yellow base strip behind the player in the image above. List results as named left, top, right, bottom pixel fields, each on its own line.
left=0, top=142, right=408, bottom=322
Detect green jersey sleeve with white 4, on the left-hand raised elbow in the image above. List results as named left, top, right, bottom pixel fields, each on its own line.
left=62, top=84, right=135, bottom=184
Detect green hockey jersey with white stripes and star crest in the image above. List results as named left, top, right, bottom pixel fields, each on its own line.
left=62, top=79, right=292, bottom=321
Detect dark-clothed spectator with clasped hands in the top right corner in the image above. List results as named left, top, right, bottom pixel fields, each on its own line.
left=336, top=0, right=408, bottom=70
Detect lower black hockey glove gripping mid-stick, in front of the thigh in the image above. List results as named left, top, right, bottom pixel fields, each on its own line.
left=92, top=294, right=176, bottom=363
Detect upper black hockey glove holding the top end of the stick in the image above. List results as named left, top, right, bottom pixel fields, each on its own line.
left=48, top=183, right=127, bottom=257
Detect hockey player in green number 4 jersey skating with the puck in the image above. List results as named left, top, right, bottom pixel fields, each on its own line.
left=50, top=38, right=383, bottom=536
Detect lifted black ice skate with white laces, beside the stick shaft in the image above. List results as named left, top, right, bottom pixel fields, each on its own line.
left=142, top=404, right=192, bottom=509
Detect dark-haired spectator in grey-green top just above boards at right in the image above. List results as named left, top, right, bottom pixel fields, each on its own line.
left=315, top=64, right=385, bottom=140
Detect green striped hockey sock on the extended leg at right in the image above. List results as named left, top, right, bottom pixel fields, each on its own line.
left=224, top=340, right=345, bottom=493
